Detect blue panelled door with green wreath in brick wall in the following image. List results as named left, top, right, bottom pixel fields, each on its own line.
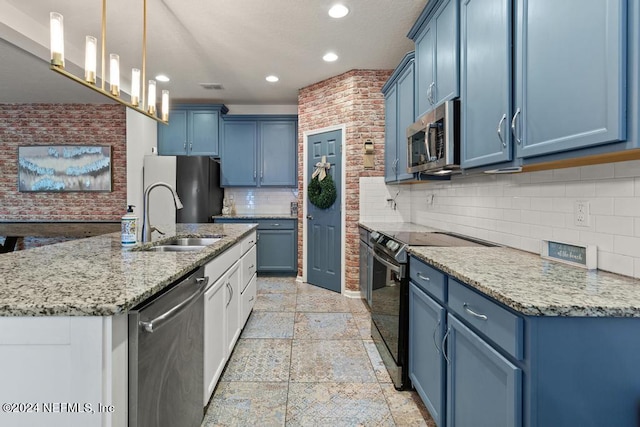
left=305, top=130, right=342, bottom=292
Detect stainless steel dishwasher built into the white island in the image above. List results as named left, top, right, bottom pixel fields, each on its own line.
left=129, top=268, right=208, bottom=427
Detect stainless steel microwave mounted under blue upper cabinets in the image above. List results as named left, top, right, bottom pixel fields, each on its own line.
left=407, top=99, right=460, bottom=175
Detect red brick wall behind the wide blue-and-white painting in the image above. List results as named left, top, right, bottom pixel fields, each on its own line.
left=0, top=104, right=127, bottom=221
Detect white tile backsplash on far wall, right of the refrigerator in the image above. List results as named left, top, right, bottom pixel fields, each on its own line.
left=224, top=187, right=300, bottom=215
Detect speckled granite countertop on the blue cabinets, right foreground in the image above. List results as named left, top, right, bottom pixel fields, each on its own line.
left=409, top=247, right=640, bottom=317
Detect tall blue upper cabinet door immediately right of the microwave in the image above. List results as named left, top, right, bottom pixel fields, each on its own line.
left=460, top=0, right=513, bottom=168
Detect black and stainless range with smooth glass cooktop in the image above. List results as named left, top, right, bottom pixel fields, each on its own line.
left=370, top=231, right=491, bottom=390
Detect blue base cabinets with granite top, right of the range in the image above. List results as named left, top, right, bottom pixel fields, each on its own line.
left=409, top=247, right=640, bottom=427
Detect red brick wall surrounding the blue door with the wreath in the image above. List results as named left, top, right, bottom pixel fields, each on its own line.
left=298, top=70, right=392, bottom=291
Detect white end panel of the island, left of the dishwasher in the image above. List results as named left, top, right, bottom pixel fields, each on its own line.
left=0, top=314, right=128, bottom=427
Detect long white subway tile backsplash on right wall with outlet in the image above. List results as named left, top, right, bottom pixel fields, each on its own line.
left=360, top=160, right=640, bottom=278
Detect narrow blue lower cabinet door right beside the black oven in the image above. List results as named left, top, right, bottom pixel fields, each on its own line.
left=409, top=283, right=446, bottom=427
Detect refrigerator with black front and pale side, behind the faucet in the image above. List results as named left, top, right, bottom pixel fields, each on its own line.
left=144, top=156, right=224, bottom=224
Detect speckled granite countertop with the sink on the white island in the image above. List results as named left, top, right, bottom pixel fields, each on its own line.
left=0, top=224, right=255, bottom=316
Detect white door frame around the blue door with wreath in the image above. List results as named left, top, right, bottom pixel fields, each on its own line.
left=302, top=123, right=347, bottom=295
